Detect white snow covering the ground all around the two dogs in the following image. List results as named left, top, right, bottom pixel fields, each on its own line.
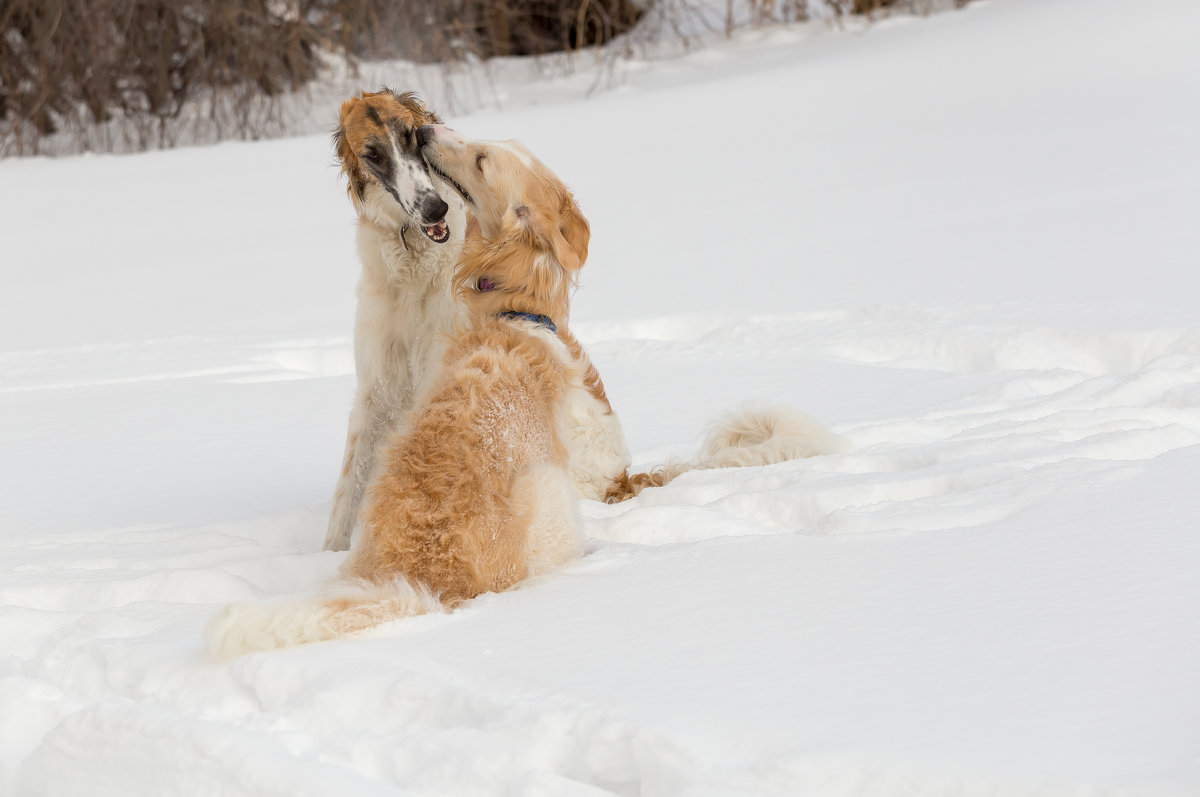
left=0, top=0, right=1200, bottom=797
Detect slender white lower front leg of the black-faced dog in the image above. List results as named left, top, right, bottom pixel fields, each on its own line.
left=325, top=390, right=389, bottom=551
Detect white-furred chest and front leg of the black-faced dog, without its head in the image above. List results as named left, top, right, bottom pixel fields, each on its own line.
left=325, top=184, right=467, bottom=551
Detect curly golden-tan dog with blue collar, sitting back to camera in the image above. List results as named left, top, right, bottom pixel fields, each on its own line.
left=208, top=127, right=604, bottom=657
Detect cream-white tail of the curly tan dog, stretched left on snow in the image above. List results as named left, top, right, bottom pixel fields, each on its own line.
left=204, top=579, right=444, bottom=659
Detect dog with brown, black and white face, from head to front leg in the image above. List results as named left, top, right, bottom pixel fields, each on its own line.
left=325, top=89, right=466, bottom=551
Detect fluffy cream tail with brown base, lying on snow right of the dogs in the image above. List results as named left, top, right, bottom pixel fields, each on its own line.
left=605, top=405, right=846, bottom=504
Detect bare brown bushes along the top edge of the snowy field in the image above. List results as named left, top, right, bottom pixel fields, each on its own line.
left=0, top=0, right=966, bottom=155
